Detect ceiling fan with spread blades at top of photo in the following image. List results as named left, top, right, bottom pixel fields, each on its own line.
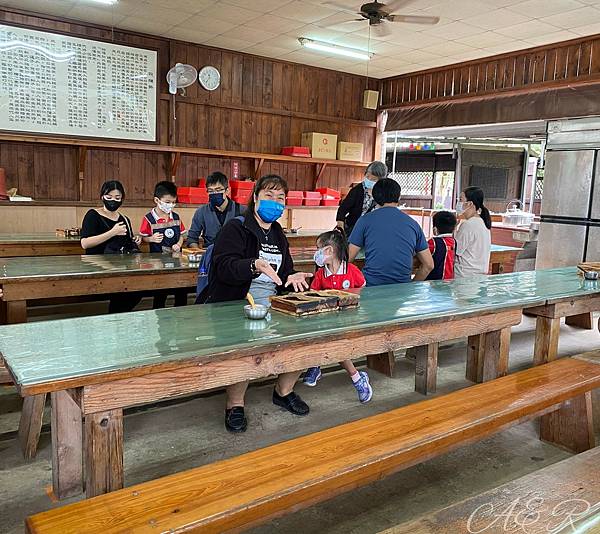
left=323, top=0, right=440, bottom=37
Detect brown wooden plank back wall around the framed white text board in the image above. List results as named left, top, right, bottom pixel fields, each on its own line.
left=0, top=8, right=376, bottom=201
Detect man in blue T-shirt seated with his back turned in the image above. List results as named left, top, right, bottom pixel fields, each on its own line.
left=349, top=178, right=433, bottom=286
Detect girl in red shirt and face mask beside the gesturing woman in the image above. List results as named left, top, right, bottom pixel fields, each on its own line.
left=304, top=228, right=373, bottom=404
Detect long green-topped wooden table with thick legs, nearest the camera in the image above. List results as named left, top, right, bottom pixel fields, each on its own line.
left=5, top=269, right=580, bottom=498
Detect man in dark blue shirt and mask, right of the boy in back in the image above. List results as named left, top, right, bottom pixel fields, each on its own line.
left=187, top=171, right=246, bottom=248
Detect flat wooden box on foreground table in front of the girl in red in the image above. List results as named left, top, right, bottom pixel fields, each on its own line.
left=270, top=289, right=360, bottom=316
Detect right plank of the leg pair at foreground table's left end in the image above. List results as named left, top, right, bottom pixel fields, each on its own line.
left=85, top=409, right=123, bottom=498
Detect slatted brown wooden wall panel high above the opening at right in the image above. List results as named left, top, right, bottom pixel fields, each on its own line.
left=380, top=35, right=600, bottom=108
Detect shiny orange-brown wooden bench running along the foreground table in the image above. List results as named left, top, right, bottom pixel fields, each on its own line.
left=26, top=358, right=600, bottom=534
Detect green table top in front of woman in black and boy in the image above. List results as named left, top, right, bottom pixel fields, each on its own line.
left=0, top=253, right=198, bottom=284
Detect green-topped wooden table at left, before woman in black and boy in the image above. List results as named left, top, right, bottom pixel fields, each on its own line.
left=0, top=254, right=198, bottom=324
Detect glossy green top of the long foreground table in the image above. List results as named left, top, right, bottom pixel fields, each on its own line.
left=0, top=267, right=600, bottom=387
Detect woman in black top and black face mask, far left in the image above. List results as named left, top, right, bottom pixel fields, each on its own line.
left=81, top=180, right=141, bottom=313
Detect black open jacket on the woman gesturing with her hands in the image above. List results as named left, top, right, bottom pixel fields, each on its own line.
left=196, top=215, right=294, bottom=303
